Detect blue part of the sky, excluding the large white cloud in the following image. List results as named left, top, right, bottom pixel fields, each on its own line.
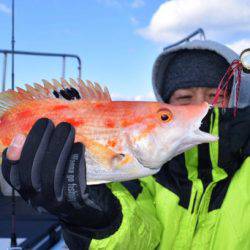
left=0, top=0, right=164, bottom=98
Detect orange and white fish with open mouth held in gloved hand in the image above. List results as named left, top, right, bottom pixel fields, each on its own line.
left=0, top=79, right=218, bottom=185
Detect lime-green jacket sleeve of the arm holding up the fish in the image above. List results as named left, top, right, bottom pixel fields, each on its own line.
left=61, top=177, right=161, bottom=250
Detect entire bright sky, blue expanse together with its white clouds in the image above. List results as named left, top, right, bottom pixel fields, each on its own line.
left=0, top=0, right=250, bottom=100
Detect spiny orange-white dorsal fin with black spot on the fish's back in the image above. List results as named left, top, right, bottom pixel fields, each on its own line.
left=0, top=78, right=111, bottom=115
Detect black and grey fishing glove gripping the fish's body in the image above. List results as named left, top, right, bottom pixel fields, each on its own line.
left=2, top=118, right=121, bottom=238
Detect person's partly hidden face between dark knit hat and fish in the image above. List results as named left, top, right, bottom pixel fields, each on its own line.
left=169, top=87, right=229, bottom=107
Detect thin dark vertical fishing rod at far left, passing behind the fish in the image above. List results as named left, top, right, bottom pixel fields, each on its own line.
left=11, top=0, right=17, bottom=247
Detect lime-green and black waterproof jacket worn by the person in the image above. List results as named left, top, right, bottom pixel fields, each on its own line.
left=65, top=109, right=250, bottom=250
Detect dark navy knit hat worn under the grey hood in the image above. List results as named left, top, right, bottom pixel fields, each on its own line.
left=160, top=49, right=229, bottom=102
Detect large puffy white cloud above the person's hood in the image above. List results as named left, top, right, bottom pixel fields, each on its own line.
left=137, top=0, right=250, bottom=44
